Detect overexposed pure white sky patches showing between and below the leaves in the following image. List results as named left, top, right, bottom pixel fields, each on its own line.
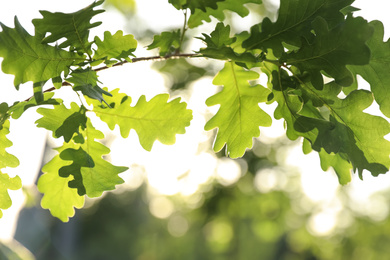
left=0, top=0, right=390, bottom=239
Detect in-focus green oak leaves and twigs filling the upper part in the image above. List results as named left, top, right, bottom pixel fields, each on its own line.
left=0, top=0, right=390, bottom=221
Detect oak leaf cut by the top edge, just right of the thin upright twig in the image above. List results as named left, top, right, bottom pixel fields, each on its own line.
left=188, top=0, right=262, bottom=28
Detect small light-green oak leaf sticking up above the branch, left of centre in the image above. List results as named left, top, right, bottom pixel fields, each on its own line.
left=93, top=31, right=137, bottom=65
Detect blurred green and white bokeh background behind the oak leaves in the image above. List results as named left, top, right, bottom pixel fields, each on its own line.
left=0, top=0, right=390, bottom=260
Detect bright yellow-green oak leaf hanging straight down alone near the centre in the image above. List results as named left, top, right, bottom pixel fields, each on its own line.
left=205, top=62, right=272, bottom=158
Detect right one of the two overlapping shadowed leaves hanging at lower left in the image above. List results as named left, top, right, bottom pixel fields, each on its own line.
left=59, top=120, right=127, bottom=197
